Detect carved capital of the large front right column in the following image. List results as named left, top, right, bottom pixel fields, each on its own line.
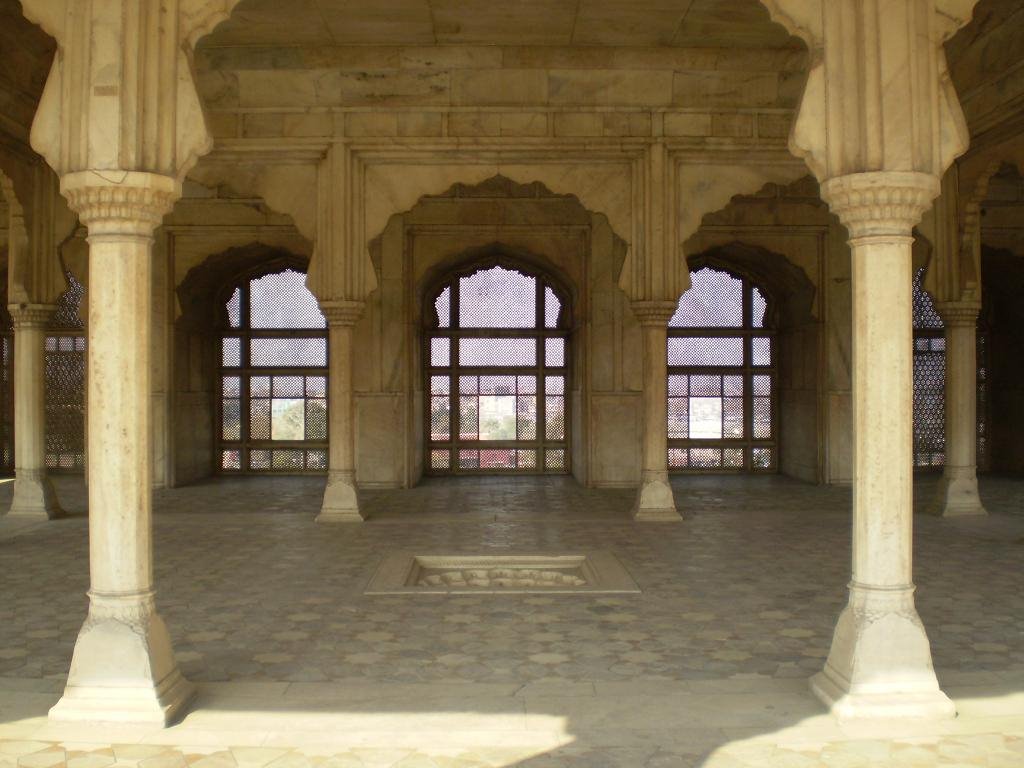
left=821, top=171, right=939, bottom=240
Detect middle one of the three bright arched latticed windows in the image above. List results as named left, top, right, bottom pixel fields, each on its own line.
left=425, top=265, right=569, bottom=474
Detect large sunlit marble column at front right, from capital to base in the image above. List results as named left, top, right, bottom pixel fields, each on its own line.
left=811, top=172, right=954, bottom=718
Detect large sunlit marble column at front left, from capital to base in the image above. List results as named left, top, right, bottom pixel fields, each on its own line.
left=50, top=171, right=193, bottom=726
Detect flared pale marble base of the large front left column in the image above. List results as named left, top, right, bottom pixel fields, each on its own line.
left=50, top=595, right=195, bottom=727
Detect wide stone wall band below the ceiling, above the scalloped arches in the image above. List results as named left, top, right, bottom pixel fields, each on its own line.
left=196, top=45, right=807, bottom=144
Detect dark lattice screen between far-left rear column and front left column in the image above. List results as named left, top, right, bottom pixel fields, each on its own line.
left=44, top=273, right=85, bottom=472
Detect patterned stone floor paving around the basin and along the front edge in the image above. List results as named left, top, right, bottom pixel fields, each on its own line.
left=0, top=477, right=1024, bottom=768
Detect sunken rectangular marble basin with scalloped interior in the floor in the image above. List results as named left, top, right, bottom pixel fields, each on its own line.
left=366, top=551, right=640, bottom=595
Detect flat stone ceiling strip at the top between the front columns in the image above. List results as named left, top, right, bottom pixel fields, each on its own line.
left=203, top=0, right=802, bottom=48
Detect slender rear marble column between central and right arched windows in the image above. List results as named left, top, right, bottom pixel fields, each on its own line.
left=632, top=301, right=682, bottom=522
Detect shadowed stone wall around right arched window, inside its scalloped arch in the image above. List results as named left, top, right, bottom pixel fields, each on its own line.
left=685, top=177, right=852, bottom=482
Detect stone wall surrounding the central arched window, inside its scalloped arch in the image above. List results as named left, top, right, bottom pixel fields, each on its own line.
left=353, top=177, right=641, bottom=487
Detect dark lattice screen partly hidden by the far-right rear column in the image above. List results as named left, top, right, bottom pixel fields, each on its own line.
left=913, top=267, right=988, bottom=468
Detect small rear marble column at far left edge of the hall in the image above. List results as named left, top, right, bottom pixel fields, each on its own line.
left=7, top=304, right=63, bottom=520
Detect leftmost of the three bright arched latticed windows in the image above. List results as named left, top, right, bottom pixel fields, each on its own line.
left=217, top=269, right=328, bottom=473
